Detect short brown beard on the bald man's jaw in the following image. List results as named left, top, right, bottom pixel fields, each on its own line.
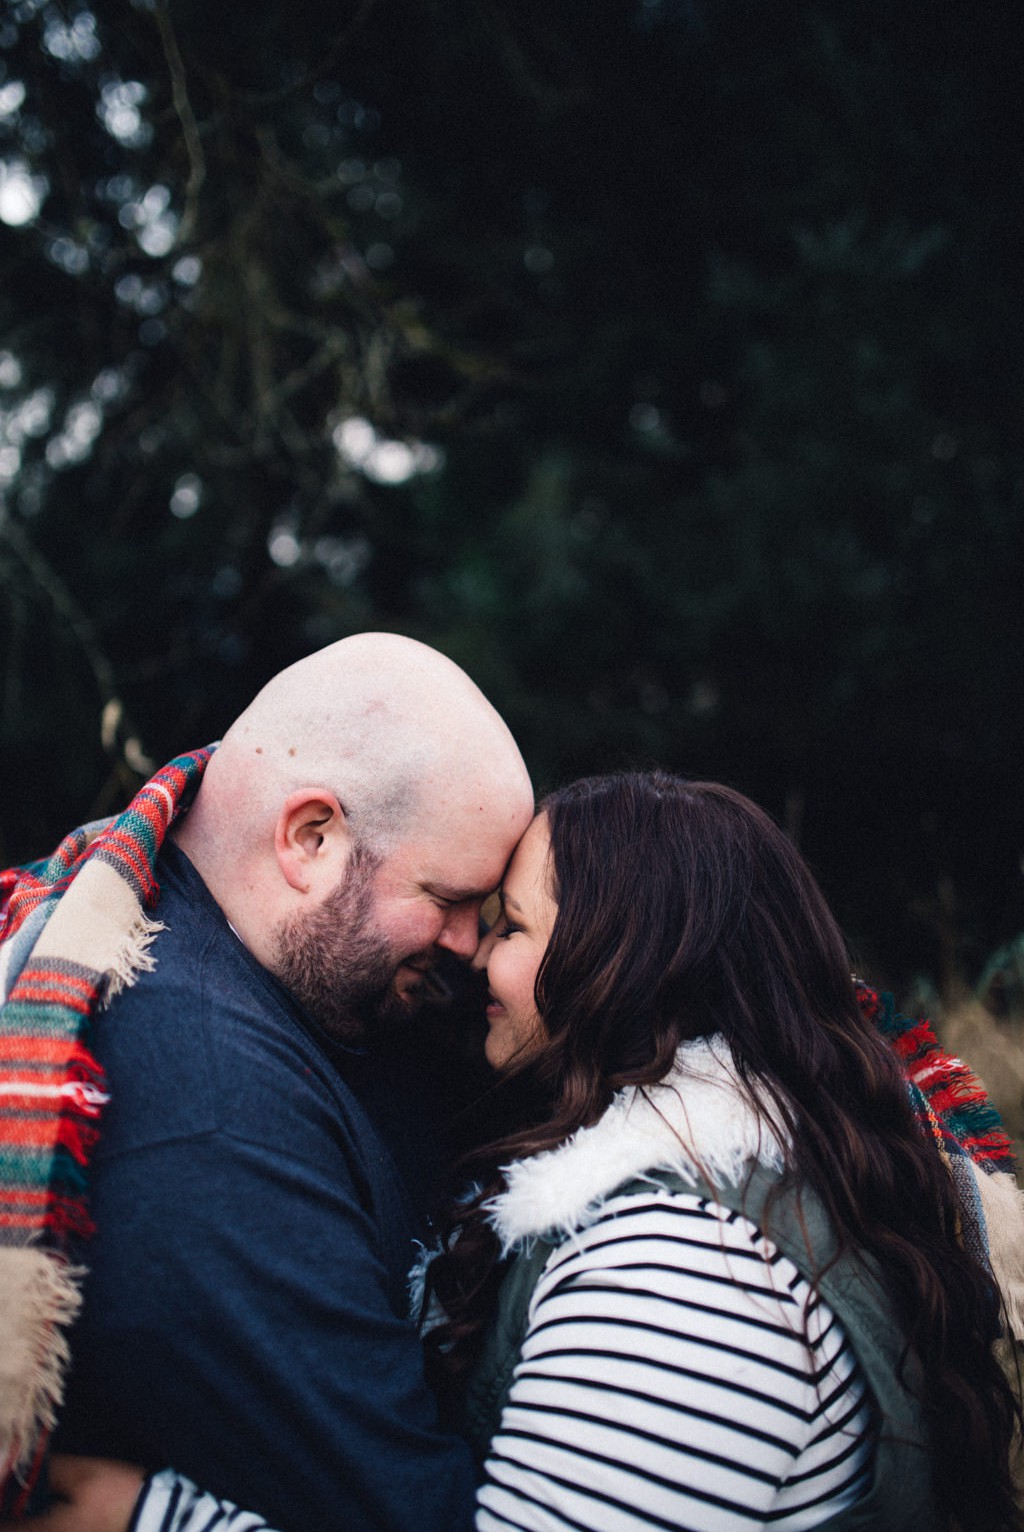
left=274, top=847, right=411, bottom=1043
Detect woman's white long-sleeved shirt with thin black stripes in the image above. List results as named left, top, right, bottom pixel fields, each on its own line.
left=125, top=1190, right=872, bottom=1532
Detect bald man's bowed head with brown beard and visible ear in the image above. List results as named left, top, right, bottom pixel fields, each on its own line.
left=178, top=633, right=533, bottom=1036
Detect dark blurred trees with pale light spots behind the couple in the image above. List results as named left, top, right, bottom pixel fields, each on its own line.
left=0, top=0, right=1024, bottom=1097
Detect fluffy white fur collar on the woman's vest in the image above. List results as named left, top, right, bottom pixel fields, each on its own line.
left=487, top=1037, right=783, bottom=1253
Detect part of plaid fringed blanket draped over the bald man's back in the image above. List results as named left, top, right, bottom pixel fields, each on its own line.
left=0, top=749, right=212, bottom=1515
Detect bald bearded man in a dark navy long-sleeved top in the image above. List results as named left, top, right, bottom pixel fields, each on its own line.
left=58, top=634, right=533, bottom=1532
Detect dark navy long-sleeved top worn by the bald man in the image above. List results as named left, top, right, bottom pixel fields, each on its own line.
left=57, top=846, right=474, bottom=1532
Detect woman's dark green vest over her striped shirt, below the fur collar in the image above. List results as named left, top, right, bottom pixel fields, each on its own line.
left=463, top=1164, right=938, bottom=1532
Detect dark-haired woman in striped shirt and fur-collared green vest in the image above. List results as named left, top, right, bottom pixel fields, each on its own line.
left=37, top=774, right=1021, bottom=1532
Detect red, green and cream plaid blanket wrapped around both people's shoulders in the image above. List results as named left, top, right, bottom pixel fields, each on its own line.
left=0, top=748, right=1024, bottom=1515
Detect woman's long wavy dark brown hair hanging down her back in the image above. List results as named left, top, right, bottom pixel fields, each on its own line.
left=428, top=772, right=1022, bottom=1532
